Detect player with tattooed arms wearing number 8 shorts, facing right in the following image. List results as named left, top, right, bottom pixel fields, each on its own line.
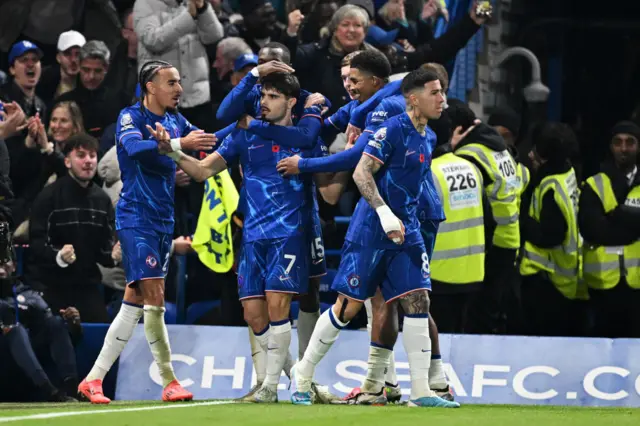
left=291, top=68, right=459, bottom=408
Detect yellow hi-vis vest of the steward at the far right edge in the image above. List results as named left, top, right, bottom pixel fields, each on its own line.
left=584, top=173, right=640, bottom=290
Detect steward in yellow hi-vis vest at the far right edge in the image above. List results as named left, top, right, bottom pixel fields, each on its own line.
left=578, top=122, right=640, bottom=338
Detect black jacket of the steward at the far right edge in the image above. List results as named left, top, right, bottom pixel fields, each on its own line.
left=578, top=162, right=640, bottom=246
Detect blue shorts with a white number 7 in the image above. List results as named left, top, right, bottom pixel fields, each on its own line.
left=238, top=235, right=309, bottom=300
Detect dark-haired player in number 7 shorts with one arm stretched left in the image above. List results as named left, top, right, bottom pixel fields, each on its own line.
left=165, top=72, right=348, bottom=402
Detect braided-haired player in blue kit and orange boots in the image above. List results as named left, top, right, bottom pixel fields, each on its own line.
left=78, top=61, right=216, bottom=404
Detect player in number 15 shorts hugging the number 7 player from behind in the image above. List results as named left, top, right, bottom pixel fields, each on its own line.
left=217, top=42, right=349, bottom=403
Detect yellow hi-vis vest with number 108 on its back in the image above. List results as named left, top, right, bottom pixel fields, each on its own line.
left=455, top=143, right=520, bottom=249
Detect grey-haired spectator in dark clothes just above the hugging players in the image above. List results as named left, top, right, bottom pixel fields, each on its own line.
left=292, top=4, right=374, bottom=115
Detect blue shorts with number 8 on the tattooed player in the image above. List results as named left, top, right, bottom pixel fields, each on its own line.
left=331, top=241, right=431, bottom=302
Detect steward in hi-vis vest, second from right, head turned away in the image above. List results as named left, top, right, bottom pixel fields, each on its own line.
left=520, top=123, right=588, bottom=336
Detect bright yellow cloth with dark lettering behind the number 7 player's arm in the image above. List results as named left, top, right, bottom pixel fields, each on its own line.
left=191, top=170, right=240, bottom=273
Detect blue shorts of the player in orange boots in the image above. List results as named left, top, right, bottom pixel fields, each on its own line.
left=118, top=228, right=173, bottom=285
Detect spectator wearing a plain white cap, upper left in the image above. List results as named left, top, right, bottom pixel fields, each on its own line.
left=36, top=31, right=87, bottom=106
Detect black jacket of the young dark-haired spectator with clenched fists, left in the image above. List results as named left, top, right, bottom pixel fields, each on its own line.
left=27, top=175, right=114, bottom=288
